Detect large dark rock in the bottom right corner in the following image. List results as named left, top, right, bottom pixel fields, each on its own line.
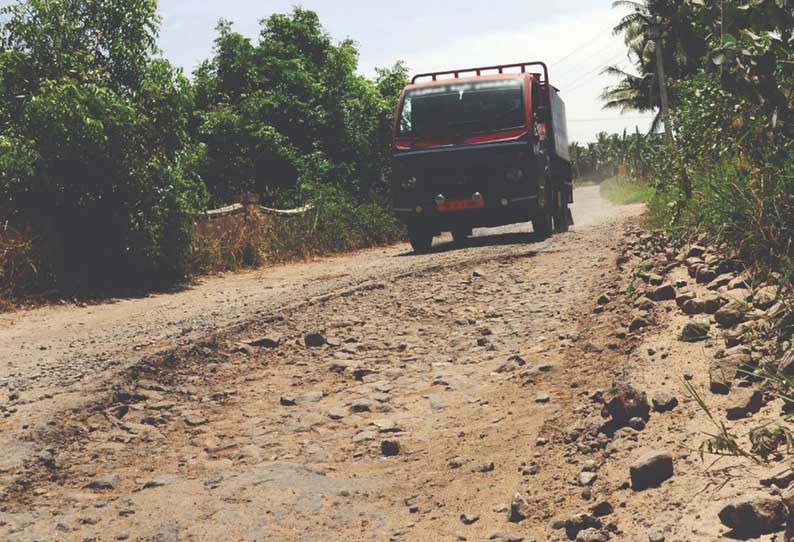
left=719, top=495, right=788, bottom=536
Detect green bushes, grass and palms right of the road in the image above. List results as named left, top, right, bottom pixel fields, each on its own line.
left=593, top=0, right=794, bottom=468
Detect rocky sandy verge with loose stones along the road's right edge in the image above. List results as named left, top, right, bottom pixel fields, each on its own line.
left=528, top=228, right=794, bottom=542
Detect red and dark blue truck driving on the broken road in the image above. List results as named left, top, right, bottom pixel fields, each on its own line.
left=391, top=61, right=573, bottom=253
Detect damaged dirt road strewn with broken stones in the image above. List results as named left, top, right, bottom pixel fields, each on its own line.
left=0, top=188, right=748, bottom=542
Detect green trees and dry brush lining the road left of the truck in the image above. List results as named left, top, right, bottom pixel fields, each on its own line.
left=0, top=0, right=407, bottom=298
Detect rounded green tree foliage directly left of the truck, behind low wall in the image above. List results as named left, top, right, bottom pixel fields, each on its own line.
left=190, top=12, right=406, bottom=209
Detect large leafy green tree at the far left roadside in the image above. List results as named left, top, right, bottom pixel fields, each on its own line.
left=0, top=0, right=205, bottom=289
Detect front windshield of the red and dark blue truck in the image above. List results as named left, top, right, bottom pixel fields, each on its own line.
left=398, top=79, right=526, bottom=138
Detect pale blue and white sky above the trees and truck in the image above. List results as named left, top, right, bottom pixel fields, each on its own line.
left=0, top=0, right=651, bottom=143
